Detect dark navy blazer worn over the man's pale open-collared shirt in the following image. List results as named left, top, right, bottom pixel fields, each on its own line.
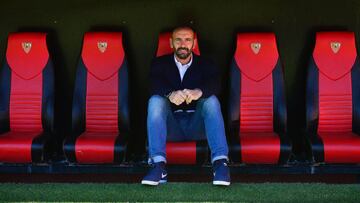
left=150, top=53, right=220, bottom=110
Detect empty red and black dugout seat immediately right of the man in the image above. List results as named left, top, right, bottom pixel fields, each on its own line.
left=228, top=33, right=291, bottom=164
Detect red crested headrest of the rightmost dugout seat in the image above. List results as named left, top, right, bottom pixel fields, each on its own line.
left=313, top=32, right=357, bottom=80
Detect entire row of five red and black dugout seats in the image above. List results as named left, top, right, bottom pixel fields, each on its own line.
left=0, top=32, right=360, bottom=164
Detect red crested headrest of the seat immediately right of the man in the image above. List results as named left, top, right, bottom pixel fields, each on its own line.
left=234, top=33, right=279, bottom=81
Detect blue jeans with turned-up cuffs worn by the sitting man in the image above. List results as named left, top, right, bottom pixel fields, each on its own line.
left=147, top=95, right=229, bottom=163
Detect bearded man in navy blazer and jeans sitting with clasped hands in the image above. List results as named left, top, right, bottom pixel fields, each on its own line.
left=141, top=27, right=230, bottom=185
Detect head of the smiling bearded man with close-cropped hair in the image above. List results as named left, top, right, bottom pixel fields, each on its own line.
left=170, top=27, right=196, bottom=60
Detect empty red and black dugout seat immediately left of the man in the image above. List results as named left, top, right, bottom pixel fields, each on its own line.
left=64, top=32, right=129, bottom=164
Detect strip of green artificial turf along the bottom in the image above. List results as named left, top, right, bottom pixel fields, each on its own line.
left=0, top=183, right=360, bottom=203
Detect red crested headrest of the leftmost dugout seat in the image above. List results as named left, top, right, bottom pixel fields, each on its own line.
left=6, top=32, right=49, bottom=80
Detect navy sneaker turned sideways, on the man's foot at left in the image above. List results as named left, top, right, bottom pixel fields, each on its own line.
left=141, top=162, right=167, bottom=185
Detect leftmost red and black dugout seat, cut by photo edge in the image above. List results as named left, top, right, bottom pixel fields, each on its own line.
left=0, top=32, right=54, bottom=163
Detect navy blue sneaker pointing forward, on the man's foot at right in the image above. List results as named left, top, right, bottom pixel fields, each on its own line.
left=213, top=159, right=230, bottom=186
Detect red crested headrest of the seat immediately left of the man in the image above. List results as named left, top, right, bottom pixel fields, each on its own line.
left=81, top=32, right=125, bottom=80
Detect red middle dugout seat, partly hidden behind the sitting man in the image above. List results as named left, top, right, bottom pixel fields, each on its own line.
left=152, top=32, right=209, bottom=165
